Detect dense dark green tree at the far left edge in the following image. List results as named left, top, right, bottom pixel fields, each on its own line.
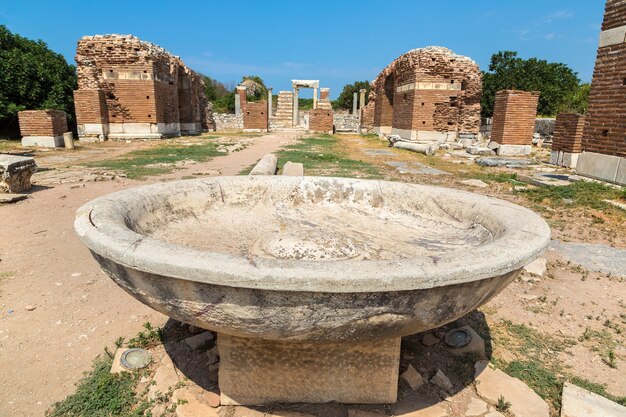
left=0, top=25, right=76, bottom=136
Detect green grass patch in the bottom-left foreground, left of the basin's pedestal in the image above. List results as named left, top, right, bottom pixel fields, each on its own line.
left=46, top=355, right=149, bottom=417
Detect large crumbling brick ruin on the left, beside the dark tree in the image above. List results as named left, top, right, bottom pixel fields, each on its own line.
left=74, top=35, right=207, bottom=136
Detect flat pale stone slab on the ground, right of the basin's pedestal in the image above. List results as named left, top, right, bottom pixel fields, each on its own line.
left=475, top=361, right=550, bottom=417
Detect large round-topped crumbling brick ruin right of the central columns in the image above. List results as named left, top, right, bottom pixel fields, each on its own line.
left=364, top=47, right=482, bottom=134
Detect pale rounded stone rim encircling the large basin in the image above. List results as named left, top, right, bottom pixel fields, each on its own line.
left=74, top=176, right=550, bottom=293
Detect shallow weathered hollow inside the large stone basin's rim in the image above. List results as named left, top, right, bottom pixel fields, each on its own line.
left=133, top=178, right=501, bottom=261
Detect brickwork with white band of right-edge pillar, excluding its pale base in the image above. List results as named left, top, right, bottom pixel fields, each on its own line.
left=582, top=0, right=626, bottom=158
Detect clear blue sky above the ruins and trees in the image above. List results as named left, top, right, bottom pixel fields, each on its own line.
left=0, top=0, right=604, bottom=97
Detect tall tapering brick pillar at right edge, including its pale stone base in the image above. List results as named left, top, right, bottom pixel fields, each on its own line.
left=576, top=0, right=626, bottom=185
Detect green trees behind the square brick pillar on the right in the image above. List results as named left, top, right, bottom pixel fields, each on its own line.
left=481, top=51, right=580, bottom=117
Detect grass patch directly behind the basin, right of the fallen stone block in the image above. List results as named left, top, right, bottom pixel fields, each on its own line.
left=272, top=134, right=382, bottom=179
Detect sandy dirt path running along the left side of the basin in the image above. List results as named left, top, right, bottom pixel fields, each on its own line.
left=0, top=132, right=297, bottom=417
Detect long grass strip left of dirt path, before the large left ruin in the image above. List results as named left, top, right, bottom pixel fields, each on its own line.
left=86, top=141, right=224, bottom=179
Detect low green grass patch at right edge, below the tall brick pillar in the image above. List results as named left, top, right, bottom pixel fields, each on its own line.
left=520, top=181, right=626, bottom=210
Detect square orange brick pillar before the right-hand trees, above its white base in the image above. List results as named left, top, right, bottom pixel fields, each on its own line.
left=491, top=90, right=539, bottom=145
